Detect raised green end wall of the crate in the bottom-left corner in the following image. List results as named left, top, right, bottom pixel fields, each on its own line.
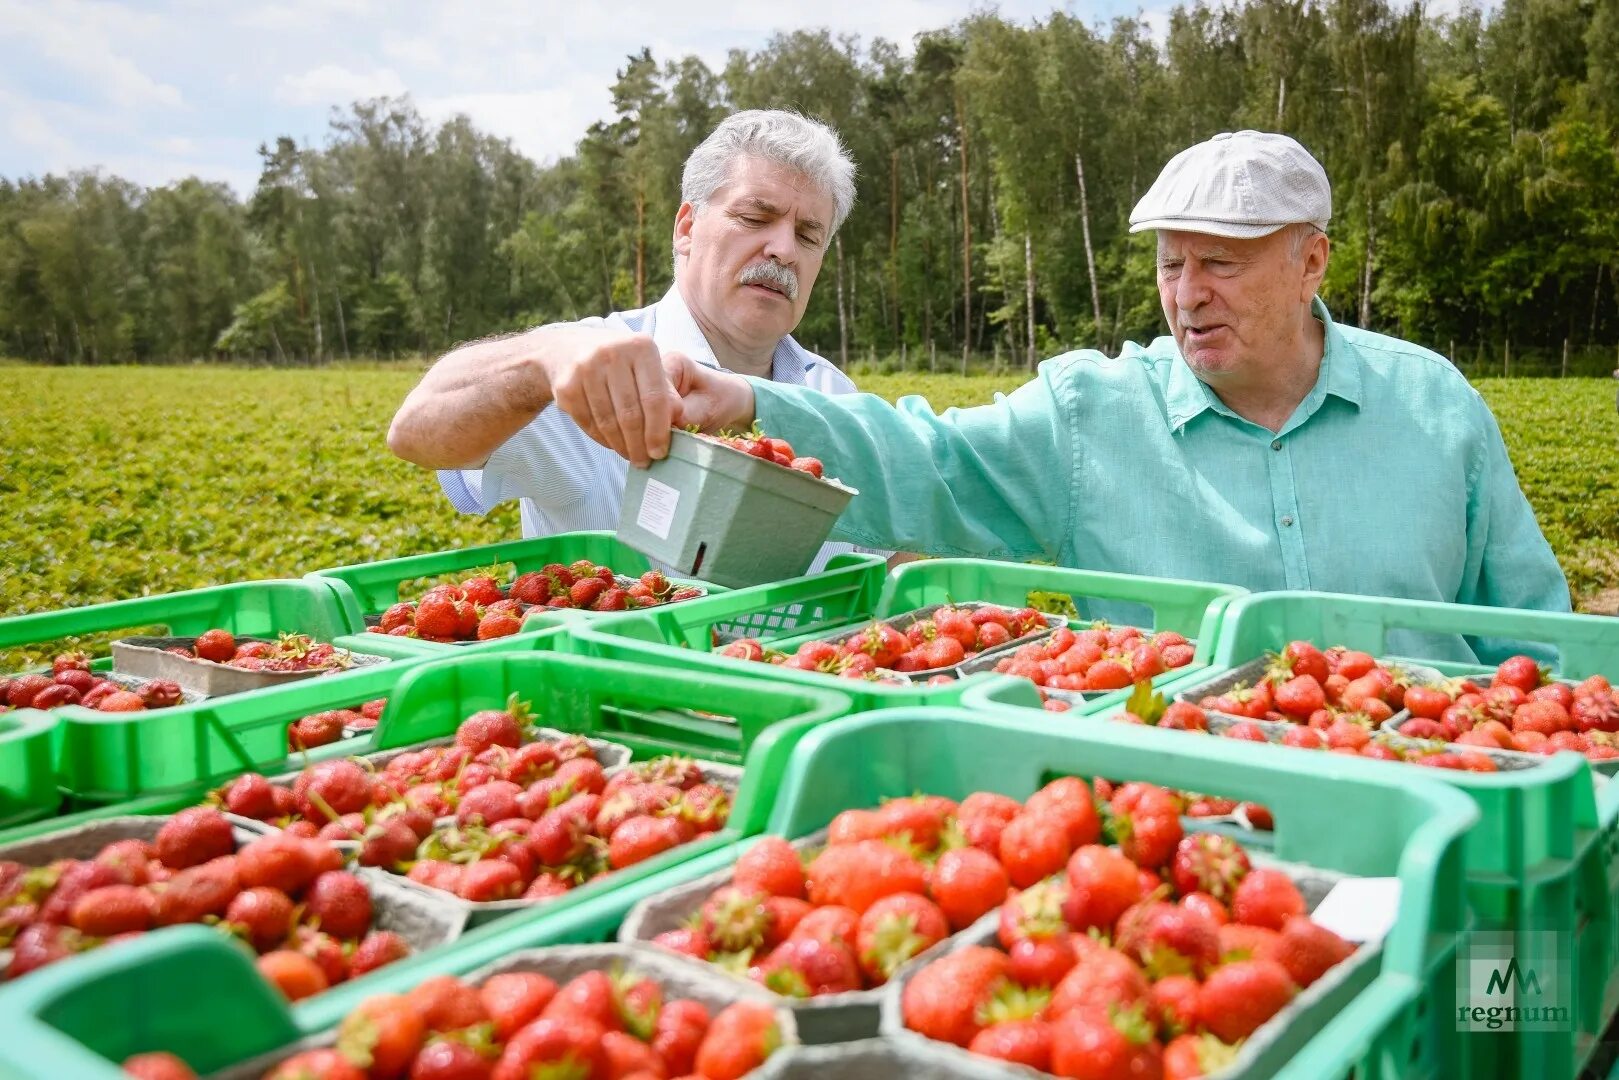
left=0, top=926, right=301, bottom=1077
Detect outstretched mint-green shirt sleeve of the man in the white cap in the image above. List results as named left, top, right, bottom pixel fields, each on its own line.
left=753, top=359, right=1075, bottom=560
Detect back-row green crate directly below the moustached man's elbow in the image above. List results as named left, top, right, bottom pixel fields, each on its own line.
left=308, top=531, right=724, bottom=656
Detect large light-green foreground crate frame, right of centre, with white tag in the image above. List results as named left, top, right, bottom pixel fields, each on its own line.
left=769, top=708, right=1478, bottom=1080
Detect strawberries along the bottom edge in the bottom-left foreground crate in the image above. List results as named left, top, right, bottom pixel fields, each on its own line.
left=125, top=972, right=782, bottom=1080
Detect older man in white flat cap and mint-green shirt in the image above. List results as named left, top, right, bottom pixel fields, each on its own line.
left=560, top=131, right=1569, bottom=657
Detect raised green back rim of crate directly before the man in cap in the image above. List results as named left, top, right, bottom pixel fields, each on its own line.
left=877, top=559, right=1248, bottom=647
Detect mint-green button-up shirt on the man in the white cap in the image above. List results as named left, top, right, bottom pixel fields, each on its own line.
left=753, top=300, right=1569, bottom=659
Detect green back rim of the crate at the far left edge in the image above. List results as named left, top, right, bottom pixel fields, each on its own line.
left=0, top=578, right=366, bottom=648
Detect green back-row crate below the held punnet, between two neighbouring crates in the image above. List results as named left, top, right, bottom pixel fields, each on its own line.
left=570, top=555, right=1242, bottom=711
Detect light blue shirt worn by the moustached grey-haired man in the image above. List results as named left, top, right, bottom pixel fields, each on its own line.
left=439, top=285, right=887, bottom=570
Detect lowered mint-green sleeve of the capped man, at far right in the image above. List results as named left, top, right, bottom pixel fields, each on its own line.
left=1455, top=398, right=1570, bottom=664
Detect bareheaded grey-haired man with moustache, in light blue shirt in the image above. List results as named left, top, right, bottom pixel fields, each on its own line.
left=389, top=110, right=880, bottom=567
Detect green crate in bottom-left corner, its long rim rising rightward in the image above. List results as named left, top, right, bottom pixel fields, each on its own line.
left=0, top=845, right=751, bottom=1080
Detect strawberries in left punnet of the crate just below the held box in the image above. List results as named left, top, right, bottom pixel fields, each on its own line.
left=720, top=604, right=1046, bottom=682
